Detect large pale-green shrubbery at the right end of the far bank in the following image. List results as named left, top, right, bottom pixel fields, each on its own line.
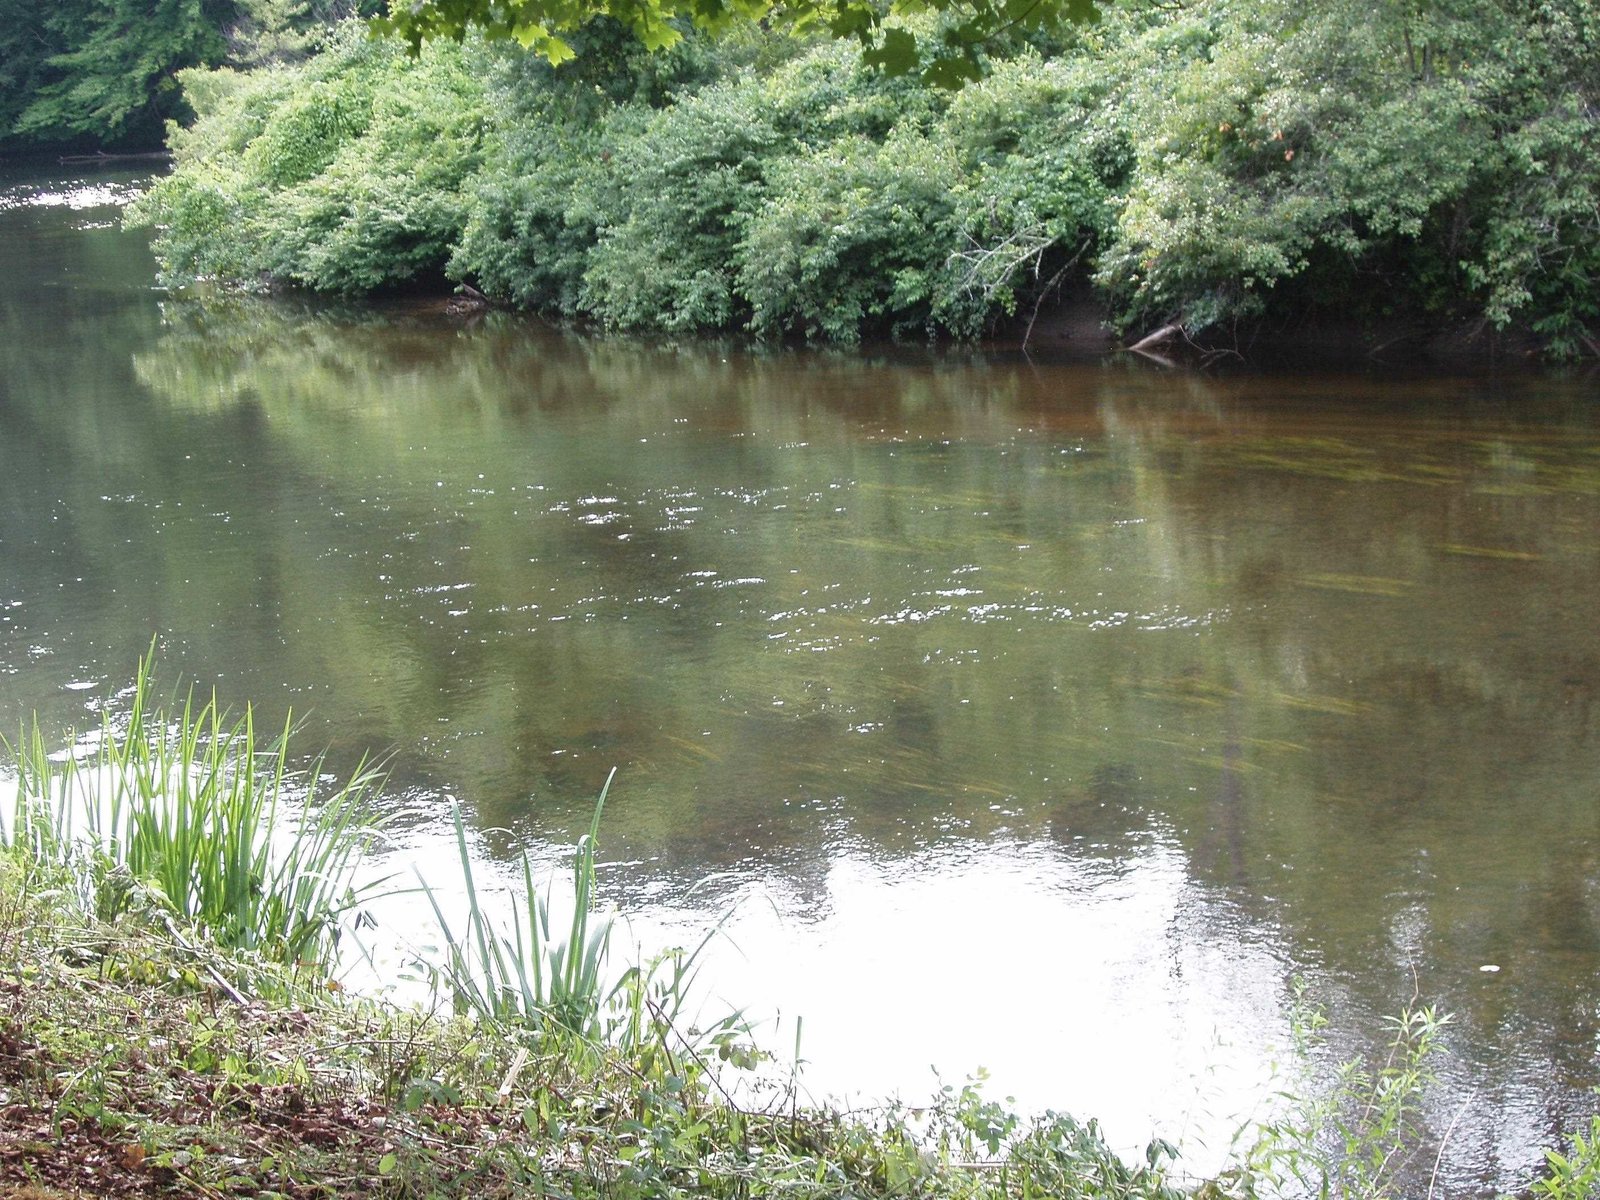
left=1099, top=0, right=1600, bottom=352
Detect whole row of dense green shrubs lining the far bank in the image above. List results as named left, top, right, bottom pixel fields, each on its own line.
left=139, top=0, right=1600, bottom=354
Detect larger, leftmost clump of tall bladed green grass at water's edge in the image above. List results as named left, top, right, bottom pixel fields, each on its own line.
left=0, top=656, right=379, bottom=965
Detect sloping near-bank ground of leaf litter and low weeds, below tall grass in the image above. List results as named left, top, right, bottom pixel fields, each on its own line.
left=0, top=825, right=1179, bottom=1200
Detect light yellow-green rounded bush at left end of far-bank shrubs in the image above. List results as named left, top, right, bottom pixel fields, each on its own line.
left=130, top=26, right=485, bottom=293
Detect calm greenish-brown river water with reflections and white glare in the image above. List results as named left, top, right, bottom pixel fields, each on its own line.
left=0, top=171, right=1600, bottom=1195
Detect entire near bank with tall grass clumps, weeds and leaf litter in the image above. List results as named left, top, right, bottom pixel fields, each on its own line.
left=0, top=672, right=1600, bottom=1200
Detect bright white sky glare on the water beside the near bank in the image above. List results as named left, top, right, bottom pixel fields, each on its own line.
left=349, top=832, right=1288, bottom=1171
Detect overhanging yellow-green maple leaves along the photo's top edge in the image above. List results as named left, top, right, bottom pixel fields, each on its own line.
left=378, top=0, right=1099, bottom=86
